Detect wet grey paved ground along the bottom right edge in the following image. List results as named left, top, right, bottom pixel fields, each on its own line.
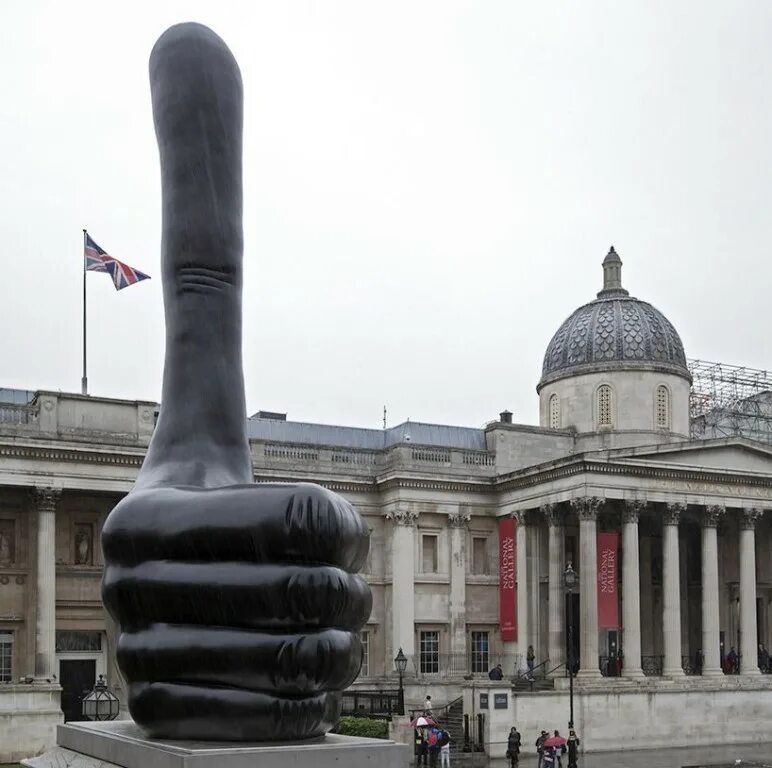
left=456, top=742, right=772, bottom=768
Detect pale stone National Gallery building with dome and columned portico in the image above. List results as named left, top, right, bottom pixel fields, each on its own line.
left=0, top=248, right=772, bottom=762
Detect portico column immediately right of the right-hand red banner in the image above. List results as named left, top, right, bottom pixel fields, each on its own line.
left=622, top=501, right=646, bottom=677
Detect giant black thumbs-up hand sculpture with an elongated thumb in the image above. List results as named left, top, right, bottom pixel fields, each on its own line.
left=102, top=24, right=371, bottom=741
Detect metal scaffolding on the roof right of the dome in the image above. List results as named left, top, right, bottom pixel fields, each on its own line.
left=688, top=360, right=772, bottom=443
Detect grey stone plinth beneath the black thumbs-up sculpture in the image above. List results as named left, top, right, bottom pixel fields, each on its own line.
left=23, top=720, right=409, bottom=768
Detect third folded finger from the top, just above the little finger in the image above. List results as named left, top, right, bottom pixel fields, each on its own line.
left=118, top=624, right=362, bottom=696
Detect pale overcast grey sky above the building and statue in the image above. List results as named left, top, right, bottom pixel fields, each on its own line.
left=0, top=0, right=772, bottom=426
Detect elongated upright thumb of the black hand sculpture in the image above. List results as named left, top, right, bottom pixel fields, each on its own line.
left=137, top=24, right=252, bottom=487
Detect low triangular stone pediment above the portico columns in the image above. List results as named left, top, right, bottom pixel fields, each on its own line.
left=609, top=438, right=772, bottom=475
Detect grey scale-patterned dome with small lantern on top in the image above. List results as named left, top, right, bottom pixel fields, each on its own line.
left=536, top=246, right=691, bottom=391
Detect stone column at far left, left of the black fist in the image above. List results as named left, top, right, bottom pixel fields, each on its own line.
left=32, top=488, right=62, bottom=683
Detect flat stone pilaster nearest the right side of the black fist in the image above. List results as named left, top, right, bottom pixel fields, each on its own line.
left=385, top=502, right=418, bottom=665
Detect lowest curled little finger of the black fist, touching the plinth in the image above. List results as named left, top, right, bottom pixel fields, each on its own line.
left=129, top=683, right=341, bottom=741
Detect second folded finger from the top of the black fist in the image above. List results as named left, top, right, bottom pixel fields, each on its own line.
left=102, top=560, right=372, bottom=631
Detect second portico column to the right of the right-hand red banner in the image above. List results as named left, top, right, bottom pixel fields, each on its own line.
left=662, top=503, right=686, bottom=677
